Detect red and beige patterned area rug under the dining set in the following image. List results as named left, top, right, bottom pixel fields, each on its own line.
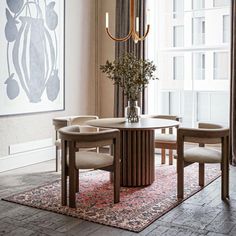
left=3, top=164, right=220, bottom=232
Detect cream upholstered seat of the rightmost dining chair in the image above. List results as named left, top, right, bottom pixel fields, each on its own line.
left=184, top=147, right=221, bottom=163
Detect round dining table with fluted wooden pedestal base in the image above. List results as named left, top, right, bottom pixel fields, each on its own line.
left=87, top=118, right=179, bottom=187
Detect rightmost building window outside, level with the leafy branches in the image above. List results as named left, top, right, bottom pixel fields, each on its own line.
left=213, top=52, right=229, bottom=80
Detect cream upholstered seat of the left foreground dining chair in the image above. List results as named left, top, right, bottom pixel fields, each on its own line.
left=67, top=151, right=113, bottom=169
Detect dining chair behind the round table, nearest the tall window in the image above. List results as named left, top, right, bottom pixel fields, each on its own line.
left=149, top=115, right=180, bottom=165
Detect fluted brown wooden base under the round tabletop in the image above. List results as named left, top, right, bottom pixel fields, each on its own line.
left=121, top=130, right=155, bottom=187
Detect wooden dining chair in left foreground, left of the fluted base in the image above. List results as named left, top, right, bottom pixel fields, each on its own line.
left=59, top=126, right=120, bottom=208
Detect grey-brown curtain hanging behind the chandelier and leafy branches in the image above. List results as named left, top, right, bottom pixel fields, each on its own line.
left=114, top=0, right=146, bottom=117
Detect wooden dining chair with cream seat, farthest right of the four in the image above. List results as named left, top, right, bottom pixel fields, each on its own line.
left=177, top=123, right=229, bottom=200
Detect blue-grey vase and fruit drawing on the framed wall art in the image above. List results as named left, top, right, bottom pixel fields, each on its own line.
left=4, top=0, right=61, bottom=104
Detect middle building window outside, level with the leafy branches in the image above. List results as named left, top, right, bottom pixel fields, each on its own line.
left=193, top=52, right=205, bottom=80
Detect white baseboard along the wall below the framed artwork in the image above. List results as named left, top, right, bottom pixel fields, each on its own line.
left=0, top=146, right=55, bottom=173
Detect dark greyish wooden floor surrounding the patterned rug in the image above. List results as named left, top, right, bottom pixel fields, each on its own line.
left=0, top=161, right=236, bottom=236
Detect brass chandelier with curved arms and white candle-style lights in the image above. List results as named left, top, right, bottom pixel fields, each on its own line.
left=106, top=0, right=150, bottom=43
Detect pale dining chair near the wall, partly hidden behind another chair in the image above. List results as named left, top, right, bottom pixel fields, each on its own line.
left=53, top=115, right=98, bottom=172
